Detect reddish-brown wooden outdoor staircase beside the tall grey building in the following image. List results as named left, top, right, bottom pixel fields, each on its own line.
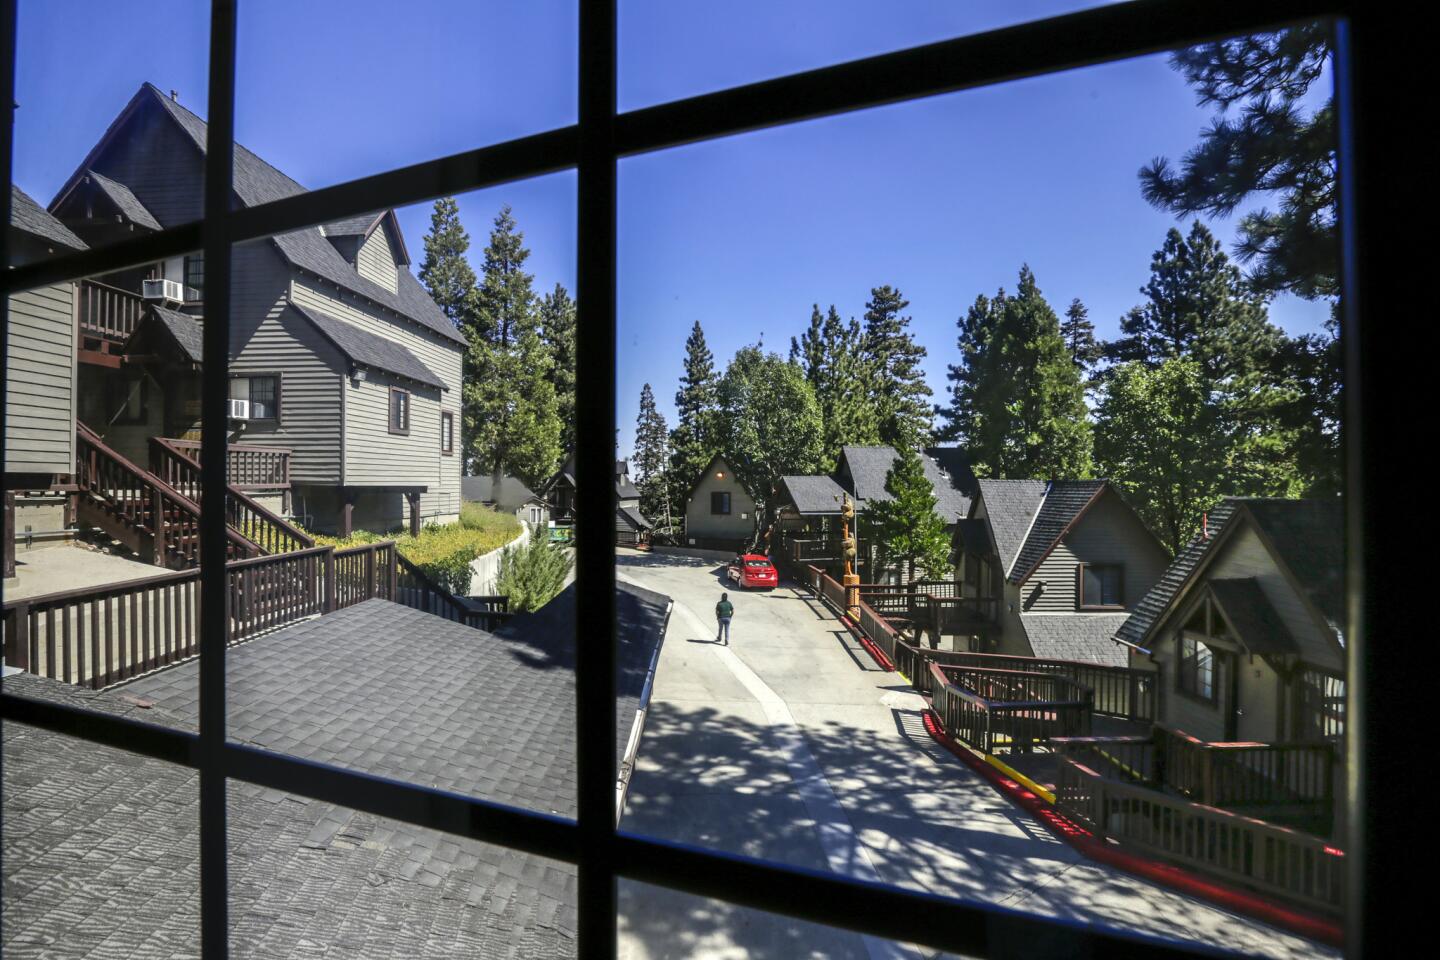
left=75, top=423, right=306, bottom=570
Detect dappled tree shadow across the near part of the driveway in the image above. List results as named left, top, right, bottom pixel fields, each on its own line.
left=622, top=701, right=1336, bottom=960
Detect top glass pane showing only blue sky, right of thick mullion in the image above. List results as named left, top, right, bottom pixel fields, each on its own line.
left=619, top=0, right=1099, bottom=109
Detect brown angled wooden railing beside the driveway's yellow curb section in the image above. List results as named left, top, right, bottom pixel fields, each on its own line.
left=930, top=664, right=1090, bottom=754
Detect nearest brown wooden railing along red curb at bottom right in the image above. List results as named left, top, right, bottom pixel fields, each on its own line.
left=1056, top=757, right=1345, bottom=913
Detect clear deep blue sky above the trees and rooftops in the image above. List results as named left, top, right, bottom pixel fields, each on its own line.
left=14, top=0, right=1328, bottom=450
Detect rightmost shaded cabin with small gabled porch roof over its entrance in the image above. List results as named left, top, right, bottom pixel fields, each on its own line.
left=1116, top=498, right=1345, bottom=743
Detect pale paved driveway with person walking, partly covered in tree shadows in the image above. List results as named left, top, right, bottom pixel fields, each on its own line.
left=616, top=551, right=1329, bottom=960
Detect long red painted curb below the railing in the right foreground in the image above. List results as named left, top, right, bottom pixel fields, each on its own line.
left=924, top=710, right=1345, bottom=947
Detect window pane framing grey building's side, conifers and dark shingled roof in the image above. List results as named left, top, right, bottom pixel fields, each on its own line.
left=213, top=176, right=576, bottom=816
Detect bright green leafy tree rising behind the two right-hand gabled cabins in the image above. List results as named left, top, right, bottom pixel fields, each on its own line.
left=1094, top=357, right=1227, bottom=553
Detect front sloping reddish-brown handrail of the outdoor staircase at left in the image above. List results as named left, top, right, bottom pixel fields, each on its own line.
left=75, top=420, right=261, bottom=566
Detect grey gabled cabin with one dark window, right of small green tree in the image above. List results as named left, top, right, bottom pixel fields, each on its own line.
left=953, top=479, right=1169, bottom=665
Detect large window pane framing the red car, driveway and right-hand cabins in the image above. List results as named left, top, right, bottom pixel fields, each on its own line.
left=616, top=29, right=1345, bottom=956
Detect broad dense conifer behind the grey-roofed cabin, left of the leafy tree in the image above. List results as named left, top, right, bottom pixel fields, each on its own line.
left=940, top=266, right=1092, bottom=479
